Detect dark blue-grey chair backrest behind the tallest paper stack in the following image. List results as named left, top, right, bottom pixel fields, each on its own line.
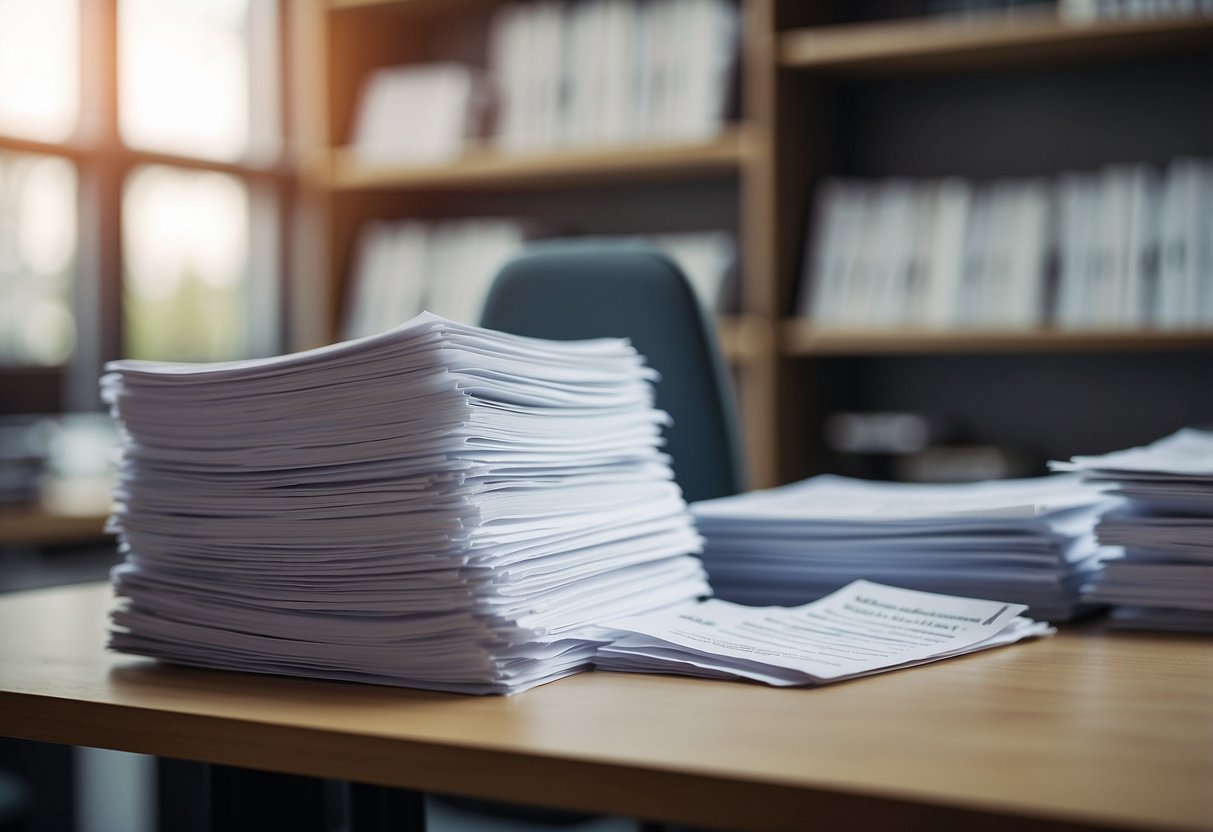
left=480, top=237, right=742, bottom=502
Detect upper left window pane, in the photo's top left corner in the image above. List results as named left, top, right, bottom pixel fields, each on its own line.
left=0, top=0, right=80, bottom=142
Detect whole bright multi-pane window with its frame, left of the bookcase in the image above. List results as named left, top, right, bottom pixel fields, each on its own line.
left=0, top=0, right=295, bottom=412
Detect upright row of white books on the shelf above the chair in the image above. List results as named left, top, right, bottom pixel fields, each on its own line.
left=486, top=0, right=739, bottom=153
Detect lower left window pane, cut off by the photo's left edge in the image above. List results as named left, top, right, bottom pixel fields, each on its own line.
left=0, top=153, right=76, bottom=365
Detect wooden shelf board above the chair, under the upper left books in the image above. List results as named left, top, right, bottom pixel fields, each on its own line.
left=311, top=130, right=745, bottom=190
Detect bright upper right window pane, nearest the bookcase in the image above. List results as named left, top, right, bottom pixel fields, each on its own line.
left=118, top=0, right=250, bottom=160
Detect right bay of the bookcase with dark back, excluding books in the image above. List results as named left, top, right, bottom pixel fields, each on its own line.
left=768, top=4, right=1213, bottom=480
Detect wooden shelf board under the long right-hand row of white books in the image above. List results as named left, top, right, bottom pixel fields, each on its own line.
left=781, top=320, right=1213, bottom=357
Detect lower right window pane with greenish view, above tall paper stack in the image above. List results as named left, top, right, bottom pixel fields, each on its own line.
left=123, top=165, right=251, bottom=361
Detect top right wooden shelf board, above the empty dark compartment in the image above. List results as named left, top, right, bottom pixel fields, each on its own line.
left=779, top=12, right=1213, bottom=74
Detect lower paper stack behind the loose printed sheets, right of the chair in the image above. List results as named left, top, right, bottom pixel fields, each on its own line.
left=691, top=475, right=1103, bottom=620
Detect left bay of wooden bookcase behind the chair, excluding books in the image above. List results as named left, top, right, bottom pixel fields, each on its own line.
left=296, top=0, right=776, bottom=484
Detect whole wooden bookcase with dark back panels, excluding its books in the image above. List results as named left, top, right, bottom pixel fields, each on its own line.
left=297, top=0, right=1213, bottom=486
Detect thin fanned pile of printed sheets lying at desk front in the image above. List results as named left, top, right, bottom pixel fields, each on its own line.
left=594, top=581, right=1054, bottom=686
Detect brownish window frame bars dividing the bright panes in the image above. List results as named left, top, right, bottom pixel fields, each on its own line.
left=0, top=0, right=301, bottom=412
